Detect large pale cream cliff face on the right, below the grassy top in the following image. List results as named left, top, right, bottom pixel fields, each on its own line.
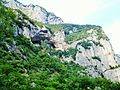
left=67, top=30, right=120, bottom=81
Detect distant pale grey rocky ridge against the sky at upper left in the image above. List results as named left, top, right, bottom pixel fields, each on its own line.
left=5, top=0, right=63, bottom=24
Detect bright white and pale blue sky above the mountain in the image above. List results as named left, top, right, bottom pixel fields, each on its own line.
left=18, top=0, right=120, bottom=54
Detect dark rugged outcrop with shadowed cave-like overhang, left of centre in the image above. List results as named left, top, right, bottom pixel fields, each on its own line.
left=14, top=10, right=51, bottom=44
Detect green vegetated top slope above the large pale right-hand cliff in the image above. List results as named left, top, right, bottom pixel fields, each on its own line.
left=65, top=25, right=108, bottom=44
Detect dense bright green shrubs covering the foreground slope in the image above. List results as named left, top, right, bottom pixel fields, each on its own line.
left=0, top=3, right=120, bottom=90
